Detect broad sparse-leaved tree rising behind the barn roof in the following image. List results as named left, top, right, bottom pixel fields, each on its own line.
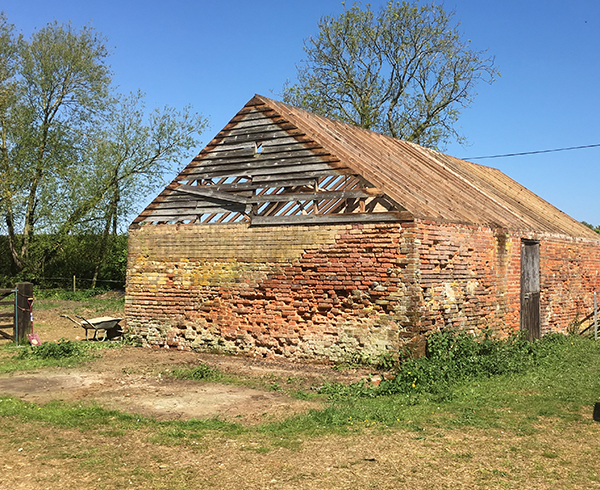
left=283, top=2, right=498, bottom=148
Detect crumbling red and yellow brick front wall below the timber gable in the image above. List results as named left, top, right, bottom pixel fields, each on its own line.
left=126, top=224, right=416, bottom=360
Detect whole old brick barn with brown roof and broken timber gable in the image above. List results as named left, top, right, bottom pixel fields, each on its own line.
left=126, top=95, right=600, bottom=361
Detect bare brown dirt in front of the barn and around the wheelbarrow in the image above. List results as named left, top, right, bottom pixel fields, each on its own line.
left=0, top=301, right=376, bottom=424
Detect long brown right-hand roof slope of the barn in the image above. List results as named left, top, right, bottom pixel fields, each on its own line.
left=256, top=95, right=588, bottom=236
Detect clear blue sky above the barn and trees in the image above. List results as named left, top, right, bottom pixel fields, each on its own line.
left=0, top=0, right=600, bottom=225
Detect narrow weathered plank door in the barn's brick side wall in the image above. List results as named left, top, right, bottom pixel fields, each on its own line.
left=521, top=240, right=541, bottom=340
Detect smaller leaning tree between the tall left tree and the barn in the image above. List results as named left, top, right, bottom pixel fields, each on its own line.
left=79, top=92, right=206, bottom=288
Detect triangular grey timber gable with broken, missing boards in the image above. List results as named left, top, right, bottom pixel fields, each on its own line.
left=133, top=101, right=412, bottom=230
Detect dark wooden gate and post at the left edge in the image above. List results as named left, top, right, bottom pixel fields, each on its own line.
left=0, top=282, right=33, bottom=345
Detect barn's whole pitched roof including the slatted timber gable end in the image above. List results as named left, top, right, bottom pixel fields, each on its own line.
left=133, top=95, right=598, bottom=239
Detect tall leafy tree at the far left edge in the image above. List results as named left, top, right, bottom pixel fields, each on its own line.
left=0, top=23, right=111, bottom=269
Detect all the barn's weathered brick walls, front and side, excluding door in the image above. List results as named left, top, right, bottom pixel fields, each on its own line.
left=126, top=220, right=600, bottom=361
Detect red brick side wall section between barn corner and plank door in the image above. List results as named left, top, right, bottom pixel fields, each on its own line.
left=417, top=221, right=520, bottom=333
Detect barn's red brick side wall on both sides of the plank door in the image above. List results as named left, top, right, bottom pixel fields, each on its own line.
left=416, top=221, right=600, bottom=334
